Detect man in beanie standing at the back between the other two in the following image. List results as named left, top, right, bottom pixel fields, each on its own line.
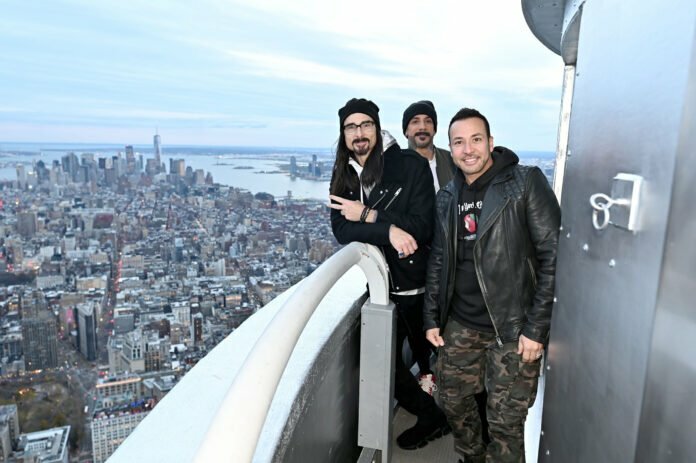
left=401, top=100, right=454, bottom=192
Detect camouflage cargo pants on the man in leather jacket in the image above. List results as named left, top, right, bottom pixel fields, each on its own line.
left=437, top=319, right=540, bottom=463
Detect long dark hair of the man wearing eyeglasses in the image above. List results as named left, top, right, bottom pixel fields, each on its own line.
left=329, top=120, right=384, bottom=196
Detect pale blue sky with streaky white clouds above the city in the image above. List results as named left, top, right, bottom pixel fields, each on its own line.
left=0, top=0, right=563, bottom=151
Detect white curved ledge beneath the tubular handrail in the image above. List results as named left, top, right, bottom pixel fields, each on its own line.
left=109, top=266, right=367, bottom=463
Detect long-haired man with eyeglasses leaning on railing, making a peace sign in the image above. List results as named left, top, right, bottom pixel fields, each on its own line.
left=330, top=98, right=450, bottom=450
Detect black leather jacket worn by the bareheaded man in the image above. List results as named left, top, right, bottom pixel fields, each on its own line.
left=423, top=154, right=561, bottom=344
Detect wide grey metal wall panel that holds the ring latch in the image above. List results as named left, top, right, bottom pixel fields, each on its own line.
left=540, top=0, right=696, bottom=463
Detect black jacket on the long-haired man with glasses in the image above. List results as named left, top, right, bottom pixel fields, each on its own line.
left=331, top=144, right=435, bottom=292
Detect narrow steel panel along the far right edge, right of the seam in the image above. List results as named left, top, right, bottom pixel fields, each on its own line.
left=636, top=26, right=696, bottom=463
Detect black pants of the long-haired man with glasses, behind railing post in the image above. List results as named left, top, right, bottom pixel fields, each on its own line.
left=390, top=294, right=442, bottom=422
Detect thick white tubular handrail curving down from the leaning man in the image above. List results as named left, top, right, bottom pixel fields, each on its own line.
left=195, top=243, right=389, bottom=463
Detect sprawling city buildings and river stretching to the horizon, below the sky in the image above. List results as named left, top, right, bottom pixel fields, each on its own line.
left=0, top=135, right=554, bottom=462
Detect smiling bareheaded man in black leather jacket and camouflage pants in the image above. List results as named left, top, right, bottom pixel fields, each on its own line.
left=423, top=108, right=560, bottom=463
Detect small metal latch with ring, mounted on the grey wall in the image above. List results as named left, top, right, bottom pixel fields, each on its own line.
left=590, top=173, right=643, bottom=233
